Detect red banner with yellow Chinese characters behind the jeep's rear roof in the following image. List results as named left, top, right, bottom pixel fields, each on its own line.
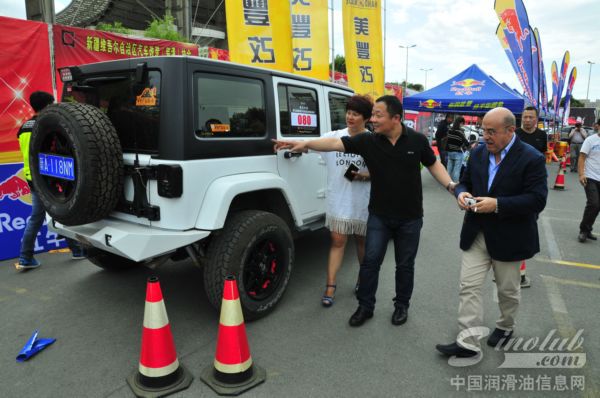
left=53, top=25, right=198, bottom=96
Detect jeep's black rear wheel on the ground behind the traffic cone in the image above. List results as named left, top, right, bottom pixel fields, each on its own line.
left=204, top=210, right=294, bottom=321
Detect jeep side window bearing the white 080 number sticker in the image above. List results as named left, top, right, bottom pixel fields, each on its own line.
left=277, top=84, right=320, bottom=137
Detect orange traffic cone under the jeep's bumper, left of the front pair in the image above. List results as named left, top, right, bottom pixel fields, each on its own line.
left=127, top=277, right=193, bottom=397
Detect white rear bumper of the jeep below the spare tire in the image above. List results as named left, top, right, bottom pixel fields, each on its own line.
left=48, top=219, right=210, bottom=261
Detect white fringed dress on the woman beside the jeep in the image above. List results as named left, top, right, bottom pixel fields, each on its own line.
left=321, top=128, right=371, bottom=236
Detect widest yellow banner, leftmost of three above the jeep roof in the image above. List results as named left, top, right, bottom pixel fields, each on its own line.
left=225, top=0, right=292, bottom=72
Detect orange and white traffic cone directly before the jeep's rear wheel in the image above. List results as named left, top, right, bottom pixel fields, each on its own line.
left=200, top=275, right=266, bottom=395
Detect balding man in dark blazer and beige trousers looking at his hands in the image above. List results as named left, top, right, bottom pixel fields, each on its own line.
left=436, top=108, right=548, bottom=357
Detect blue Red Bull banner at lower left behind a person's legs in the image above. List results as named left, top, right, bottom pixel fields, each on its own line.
left=0, top=163, right=66, bottom=260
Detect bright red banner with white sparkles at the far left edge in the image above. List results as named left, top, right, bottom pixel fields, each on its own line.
left=0, top=17, right=52, bottom=163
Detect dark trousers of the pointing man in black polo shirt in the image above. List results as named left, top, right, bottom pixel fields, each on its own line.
left=357, top=214, right=423, bottom=311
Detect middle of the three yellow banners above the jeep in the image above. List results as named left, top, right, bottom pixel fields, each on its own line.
left=291, top=0, right=329, bottom=80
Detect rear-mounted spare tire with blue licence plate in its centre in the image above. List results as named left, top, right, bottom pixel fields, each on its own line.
left=29, top=103, right=123, bottom=225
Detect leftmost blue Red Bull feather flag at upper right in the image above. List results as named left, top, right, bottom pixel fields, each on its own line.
left=494, top=0, right=538, bottom=107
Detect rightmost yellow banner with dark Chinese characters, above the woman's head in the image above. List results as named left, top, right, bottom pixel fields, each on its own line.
left=342, top=0, right=384, bottom=98
